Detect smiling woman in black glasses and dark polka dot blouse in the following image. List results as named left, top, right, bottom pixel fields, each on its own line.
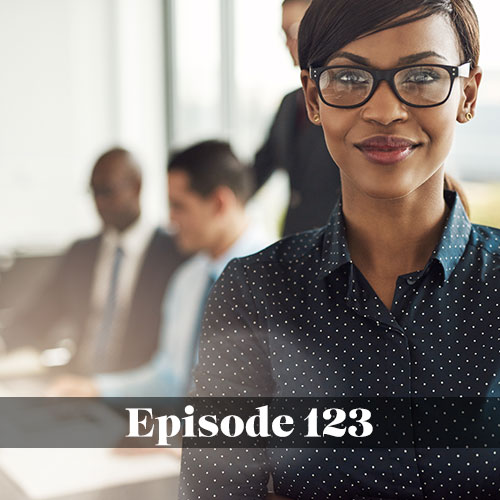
left=181, top=0, right=500, bottom=499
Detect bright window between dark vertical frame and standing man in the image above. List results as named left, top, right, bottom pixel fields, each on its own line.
left=166, top=0, right=300, bottom=158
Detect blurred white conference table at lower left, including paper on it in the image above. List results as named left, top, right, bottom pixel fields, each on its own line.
left=0, top=353, right=180, bottom=500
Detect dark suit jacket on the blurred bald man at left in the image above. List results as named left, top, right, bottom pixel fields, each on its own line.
left=4, top=229, right=183, bottom=369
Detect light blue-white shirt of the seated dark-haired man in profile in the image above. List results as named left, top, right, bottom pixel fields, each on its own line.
left=94, top=227, right=269, bottom=397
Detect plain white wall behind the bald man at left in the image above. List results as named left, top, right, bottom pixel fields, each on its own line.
left=0, top=0, right=165, bottom=253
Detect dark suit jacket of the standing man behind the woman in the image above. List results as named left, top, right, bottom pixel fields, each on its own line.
left=254, top=89, right=340, bottom=235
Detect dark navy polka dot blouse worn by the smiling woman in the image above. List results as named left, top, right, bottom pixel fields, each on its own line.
left=180, top=192, right=500, bottom=500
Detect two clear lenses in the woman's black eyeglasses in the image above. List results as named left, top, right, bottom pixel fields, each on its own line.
left=319, top=66, right=451, bottom=106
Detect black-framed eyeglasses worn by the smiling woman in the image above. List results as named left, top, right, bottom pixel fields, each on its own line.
left=309, top=61, right=471, bottom=108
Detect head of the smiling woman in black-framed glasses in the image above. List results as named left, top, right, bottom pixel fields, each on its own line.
left=301, top=2, right=481, bottom=205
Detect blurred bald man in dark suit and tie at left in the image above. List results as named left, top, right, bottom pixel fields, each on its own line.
left=0, top=148, right=183, bottom=373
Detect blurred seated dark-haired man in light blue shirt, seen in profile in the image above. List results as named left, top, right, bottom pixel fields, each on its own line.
left=50, top=141, right=266, bottom=397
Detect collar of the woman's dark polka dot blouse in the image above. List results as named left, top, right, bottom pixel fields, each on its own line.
left=318, top=191, right=472, bottom=282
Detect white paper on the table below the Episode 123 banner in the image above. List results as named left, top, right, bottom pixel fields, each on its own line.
left=0, top=448, right=180, bottom=500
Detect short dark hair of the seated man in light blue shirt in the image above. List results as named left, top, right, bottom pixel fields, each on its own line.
left=167, top=140, right=253, bottom=203
